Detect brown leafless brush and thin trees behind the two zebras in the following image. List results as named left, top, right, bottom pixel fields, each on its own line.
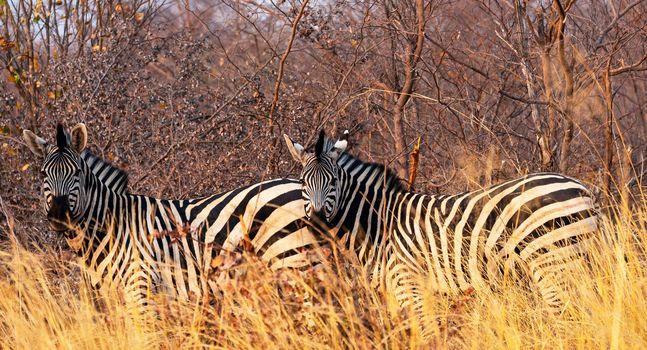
left=0, top=0, right=647, bottom=240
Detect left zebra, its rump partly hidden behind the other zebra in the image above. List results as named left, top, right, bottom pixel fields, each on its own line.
left=23, top=123, right=317, bottom=310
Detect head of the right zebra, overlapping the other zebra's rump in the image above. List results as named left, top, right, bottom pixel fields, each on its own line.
left=283, top=130, right=348, bottom=222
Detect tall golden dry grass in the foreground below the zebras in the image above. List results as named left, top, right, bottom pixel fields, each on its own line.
left=0, top=201, right=647, bottom=349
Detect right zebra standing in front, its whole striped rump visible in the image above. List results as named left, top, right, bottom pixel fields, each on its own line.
left=284, top=131, right=598, bottom=317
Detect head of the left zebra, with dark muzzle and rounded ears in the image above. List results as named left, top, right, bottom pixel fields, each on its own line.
left=22, top=123, right=88, bottom=232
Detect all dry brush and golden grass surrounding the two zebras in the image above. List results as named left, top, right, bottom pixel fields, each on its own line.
left=0, top=0, right=647, bottom=349
